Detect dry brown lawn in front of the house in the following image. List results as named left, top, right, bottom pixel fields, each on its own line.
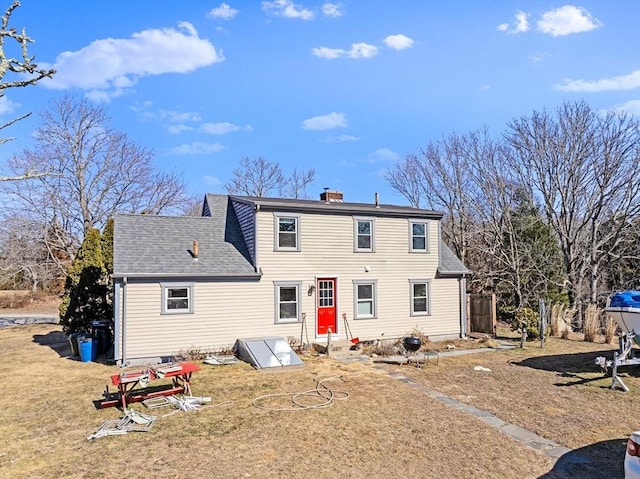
left=0, top=325, right=640, bottom=479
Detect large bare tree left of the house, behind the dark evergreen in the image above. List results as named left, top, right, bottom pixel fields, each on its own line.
left=3, top=92, right=188, bottom=268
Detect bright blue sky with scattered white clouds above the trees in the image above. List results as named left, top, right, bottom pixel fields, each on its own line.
left=0, top=0, right=640, bottom=204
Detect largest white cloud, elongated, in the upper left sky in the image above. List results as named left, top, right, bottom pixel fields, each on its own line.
left=40, top=22, right=224, bottom=98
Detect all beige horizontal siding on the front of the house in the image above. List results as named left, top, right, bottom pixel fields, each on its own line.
left=117, top=211, right=460, bottom=361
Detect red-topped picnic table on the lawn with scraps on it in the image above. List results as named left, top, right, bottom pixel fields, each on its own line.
left=100, top=362, right=200, bottom=411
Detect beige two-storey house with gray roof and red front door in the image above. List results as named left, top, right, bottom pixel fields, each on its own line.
left=113, top=191, right=469, bottom=365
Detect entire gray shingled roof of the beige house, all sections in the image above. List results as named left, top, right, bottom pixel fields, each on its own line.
left=114, top=195, right=470, bottom=277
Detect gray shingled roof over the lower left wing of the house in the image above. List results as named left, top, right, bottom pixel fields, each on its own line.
left=113, top=196, right=259, bottom=277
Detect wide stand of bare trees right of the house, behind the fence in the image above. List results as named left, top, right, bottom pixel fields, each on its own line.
left=387, top=102, right=640, bottom=312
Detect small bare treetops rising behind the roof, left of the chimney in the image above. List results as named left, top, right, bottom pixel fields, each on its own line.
left=224, top=156, right=315, bottom=198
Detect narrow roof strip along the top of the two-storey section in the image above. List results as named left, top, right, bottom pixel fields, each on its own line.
left=228, top=195, right=442, bottom=219
